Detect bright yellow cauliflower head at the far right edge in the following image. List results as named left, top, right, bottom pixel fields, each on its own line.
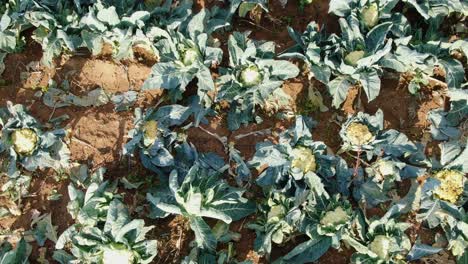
left=434, top=170, right=465, bottom=203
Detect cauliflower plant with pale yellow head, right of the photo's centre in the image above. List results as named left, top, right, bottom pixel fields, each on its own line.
left=249, top=116, right=344, bottom=196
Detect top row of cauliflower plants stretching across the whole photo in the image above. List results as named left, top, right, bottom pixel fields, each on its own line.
left=0, top=0, right=468, bottom=125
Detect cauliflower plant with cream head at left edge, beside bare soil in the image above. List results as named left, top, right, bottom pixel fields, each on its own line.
left=0, top=102, right=70, bottom=176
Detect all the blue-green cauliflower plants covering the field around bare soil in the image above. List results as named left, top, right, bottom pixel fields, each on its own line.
left=0, top=0, right=468, bottom=264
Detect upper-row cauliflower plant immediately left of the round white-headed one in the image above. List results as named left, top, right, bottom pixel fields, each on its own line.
left=142, top=8, right=228, bottom=121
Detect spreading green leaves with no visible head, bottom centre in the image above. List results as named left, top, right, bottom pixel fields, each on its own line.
left=147, top=157, right=255, bottom=251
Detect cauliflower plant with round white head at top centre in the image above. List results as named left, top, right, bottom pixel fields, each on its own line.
left=216, top=32, right=299, bottom=130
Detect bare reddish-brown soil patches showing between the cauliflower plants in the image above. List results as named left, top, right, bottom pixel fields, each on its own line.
left=0, top=0, right=456, bottom=263
